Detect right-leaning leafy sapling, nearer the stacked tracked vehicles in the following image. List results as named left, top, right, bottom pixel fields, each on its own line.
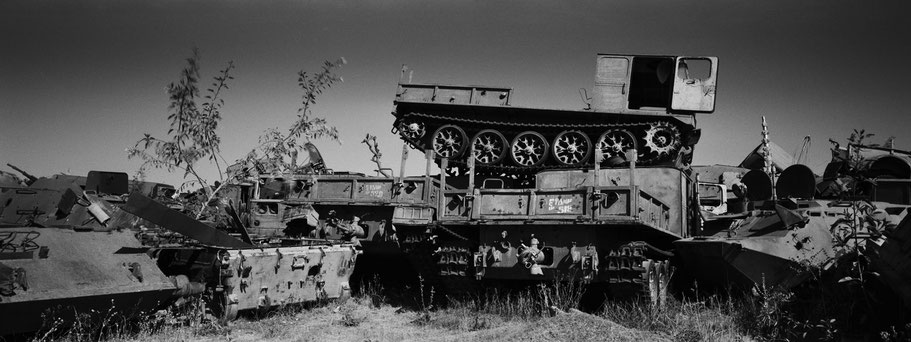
left=240, top=58, right=346, bottom=173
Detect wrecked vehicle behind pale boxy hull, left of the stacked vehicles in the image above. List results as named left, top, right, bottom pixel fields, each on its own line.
left=219, top=139, right=437, bottom=287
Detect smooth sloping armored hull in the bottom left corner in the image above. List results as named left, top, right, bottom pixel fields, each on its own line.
left=0, top=227, right=175, bottom=335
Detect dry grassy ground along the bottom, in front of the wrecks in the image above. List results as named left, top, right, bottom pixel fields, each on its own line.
left=23, top=276, right=911, bottom=342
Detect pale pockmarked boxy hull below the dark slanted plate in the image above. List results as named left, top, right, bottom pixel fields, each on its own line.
left=156, top=244, right=359, bottom=318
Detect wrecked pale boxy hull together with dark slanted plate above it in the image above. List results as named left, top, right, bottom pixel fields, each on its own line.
left=123, top=193, right=359, bottom=319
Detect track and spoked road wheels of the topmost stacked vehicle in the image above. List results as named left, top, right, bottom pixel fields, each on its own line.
left=392, top=113, right=691, bottom=174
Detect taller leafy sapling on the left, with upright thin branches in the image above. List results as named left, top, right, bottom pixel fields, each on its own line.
left=127, top=48, right=234, bottom=218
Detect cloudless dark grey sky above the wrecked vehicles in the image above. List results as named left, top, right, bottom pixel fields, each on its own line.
left=0, top=0, right=911, bottom=184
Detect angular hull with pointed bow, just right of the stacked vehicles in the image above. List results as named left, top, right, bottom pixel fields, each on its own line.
left=674, top=201, right=844, bottom=288
